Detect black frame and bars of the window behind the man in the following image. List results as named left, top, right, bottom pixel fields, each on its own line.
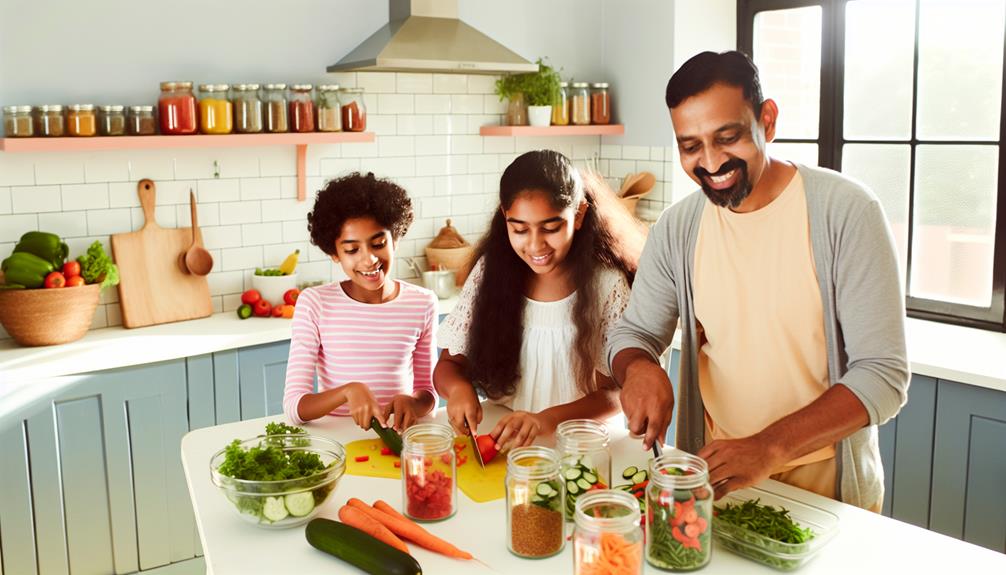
left=736, top=0, right=1006, bottom=332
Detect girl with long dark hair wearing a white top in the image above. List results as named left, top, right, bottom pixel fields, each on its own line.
left=434, top=150, right=645, bottom=448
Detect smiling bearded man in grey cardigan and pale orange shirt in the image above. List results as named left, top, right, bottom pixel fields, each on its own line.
left=607, top=51, right=908, bottom=511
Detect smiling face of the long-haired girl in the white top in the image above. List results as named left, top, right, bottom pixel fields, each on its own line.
left=503, top=190, right=586, bottom=275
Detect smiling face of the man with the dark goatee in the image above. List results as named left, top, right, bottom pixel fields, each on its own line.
left=671, top=83, right=779, bottom=208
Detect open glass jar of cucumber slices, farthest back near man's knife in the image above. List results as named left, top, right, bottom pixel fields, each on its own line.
left=555, top=419, right=607, bottom=521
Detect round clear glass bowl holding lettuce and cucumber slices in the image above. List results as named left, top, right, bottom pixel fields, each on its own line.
left=209, top=433, right=346, bottom=529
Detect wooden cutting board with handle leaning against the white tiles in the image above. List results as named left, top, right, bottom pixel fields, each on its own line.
left=112, top=180, right=213, bottom=328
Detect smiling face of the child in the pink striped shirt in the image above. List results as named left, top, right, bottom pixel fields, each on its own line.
left=332, top=217, right=394, bottom=302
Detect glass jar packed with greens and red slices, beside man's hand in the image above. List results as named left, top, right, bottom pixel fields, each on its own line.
left=646, top=450, right=712, bottom=571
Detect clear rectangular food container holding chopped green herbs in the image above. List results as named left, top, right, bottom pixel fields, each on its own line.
left=712, top=488, right=838, bottom=571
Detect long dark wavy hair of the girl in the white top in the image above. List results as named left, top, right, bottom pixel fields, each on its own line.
left=468, top=150, right=645, bottom=399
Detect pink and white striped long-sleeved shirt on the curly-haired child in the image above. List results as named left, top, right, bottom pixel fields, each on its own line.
left=283, top=281, right=437, bottom=423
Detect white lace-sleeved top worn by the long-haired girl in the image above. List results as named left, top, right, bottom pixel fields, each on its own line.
left=437, top=260, right=629, bottom=412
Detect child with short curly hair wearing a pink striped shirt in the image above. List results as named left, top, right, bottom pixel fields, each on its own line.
left=283, top=173, right=438, bottom=430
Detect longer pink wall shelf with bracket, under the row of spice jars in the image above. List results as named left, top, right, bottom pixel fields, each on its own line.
left=0, top=132, right=374, bottom=201
